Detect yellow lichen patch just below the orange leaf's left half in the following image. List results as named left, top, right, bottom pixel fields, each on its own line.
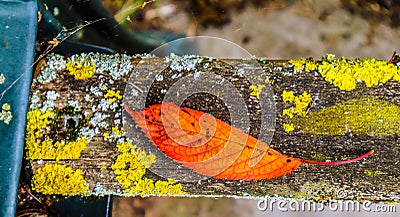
left=111, top=142, right=184, bottom=196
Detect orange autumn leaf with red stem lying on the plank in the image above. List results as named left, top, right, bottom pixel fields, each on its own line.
left=125, top=102, right=373, bottom=180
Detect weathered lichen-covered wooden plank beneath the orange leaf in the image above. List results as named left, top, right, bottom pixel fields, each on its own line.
left=26, top=53, right=400, bottom=203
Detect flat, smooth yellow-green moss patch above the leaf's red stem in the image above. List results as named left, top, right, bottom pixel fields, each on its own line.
left=291, top=98, right=400, bottom=136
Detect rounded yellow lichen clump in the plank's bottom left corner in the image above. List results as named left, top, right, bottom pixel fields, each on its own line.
left=32, top=163, right=89, bottom=196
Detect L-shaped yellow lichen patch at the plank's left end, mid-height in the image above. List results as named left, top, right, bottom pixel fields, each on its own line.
left=25, top=109, right=89, bottom=160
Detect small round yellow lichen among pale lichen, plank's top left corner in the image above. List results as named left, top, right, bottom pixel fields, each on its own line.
left=65, top=57, right=96, bottom=80
